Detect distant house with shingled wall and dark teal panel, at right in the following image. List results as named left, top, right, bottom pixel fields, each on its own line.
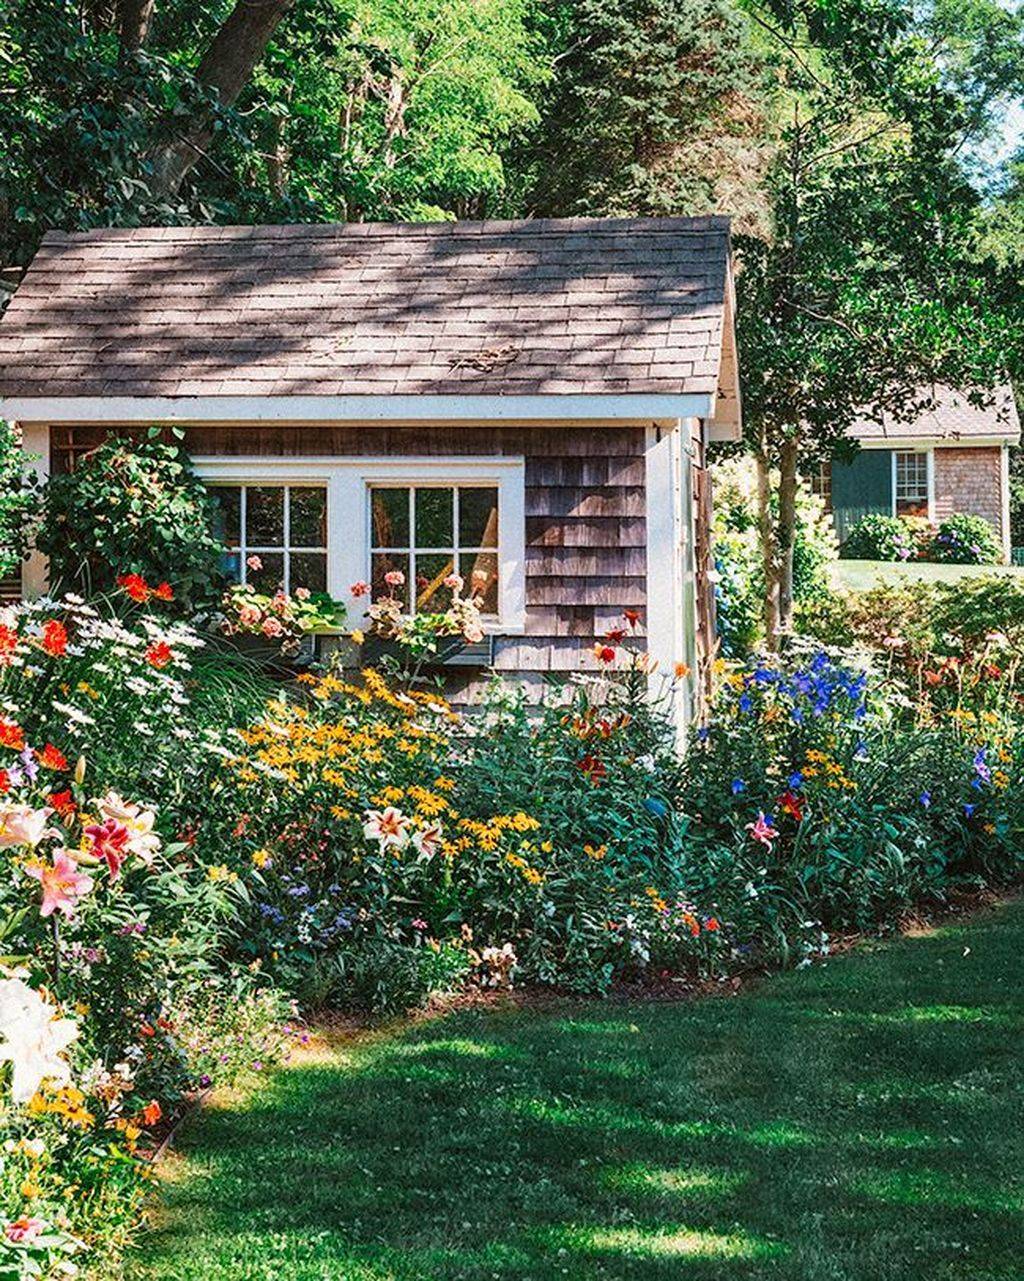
left=811, top=386, right=1020, bottom=561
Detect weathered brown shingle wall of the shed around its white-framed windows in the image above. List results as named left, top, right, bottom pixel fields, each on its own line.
left=51, top=424, right=647, bottom=696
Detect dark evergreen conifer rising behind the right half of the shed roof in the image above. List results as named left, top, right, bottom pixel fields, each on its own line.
left=516, top=0, right=763, bottom=215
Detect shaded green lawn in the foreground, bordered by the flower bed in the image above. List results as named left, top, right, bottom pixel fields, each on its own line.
left=127, top=904, right=1024, bottom=1281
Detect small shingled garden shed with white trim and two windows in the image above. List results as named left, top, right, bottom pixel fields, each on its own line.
left=0, top=218, right=739, bottom=719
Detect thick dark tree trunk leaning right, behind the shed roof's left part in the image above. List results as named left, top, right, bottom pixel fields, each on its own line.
left=150, top=0, right=292, bottom=200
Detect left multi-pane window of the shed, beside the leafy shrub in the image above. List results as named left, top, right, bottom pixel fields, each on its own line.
left=210, top=484, right=327, bottom=593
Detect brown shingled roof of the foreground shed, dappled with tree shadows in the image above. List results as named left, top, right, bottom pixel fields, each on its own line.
left=0, top=218, right=731, bottom=397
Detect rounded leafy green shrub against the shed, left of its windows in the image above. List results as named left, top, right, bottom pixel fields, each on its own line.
left=38, top=429, right=223, bottom=606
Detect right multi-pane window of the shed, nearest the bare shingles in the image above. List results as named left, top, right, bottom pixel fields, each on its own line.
left=370, top=484, right=499, bottom=616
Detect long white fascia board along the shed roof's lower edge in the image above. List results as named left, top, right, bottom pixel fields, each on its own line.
left=0, top=395, right=714, bottom=425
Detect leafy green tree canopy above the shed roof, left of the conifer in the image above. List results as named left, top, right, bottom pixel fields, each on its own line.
left=0, top=0, right=550, bottom=263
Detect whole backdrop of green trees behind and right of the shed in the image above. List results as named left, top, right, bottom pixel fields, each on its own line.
left=0, top=0, right=1024, bottom=614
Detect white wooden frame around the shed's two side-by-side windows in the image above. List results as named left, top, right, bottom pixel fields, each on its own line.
left=192, top=455, right=527, bottom=634
